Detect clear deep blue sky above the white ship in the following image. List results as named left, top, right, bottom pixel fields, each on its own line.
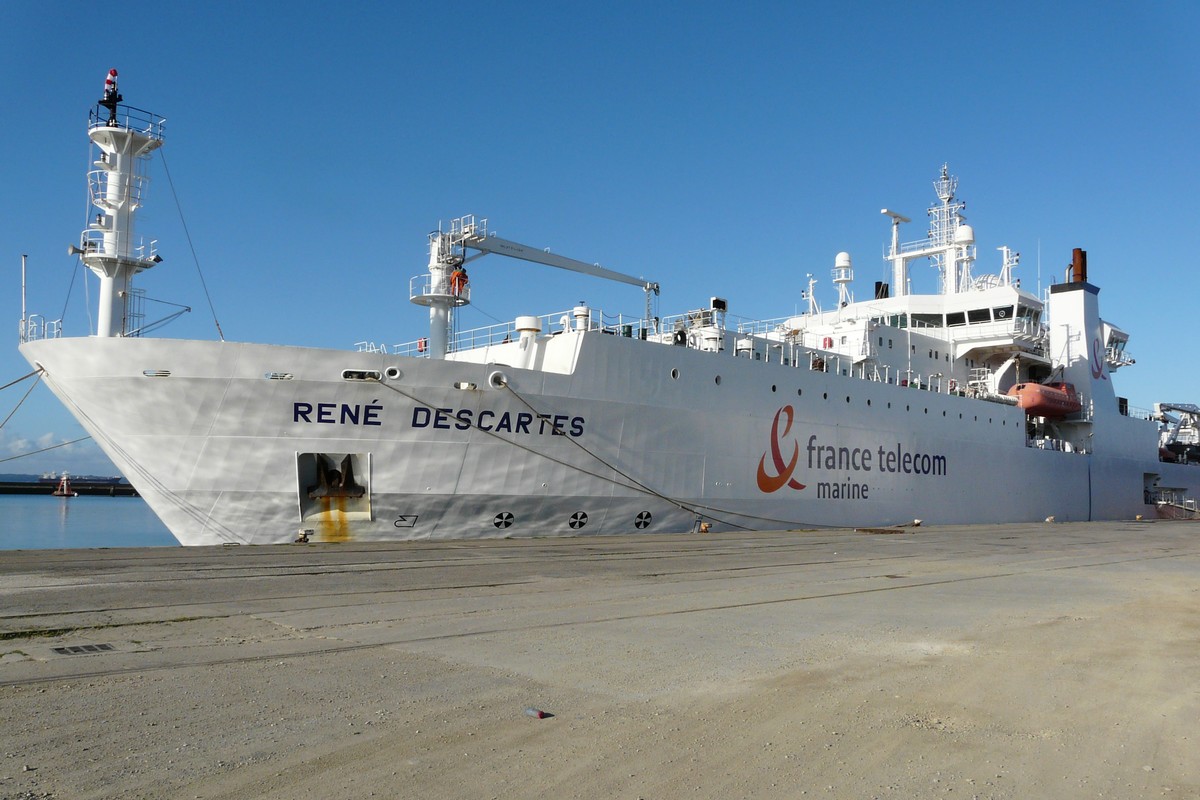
left=0, top=0, right=1200, bottom=474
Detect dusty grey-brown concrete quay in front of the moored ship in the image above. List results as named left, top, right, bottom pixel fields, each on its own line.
left=0, top=521, right=1200, bottom=798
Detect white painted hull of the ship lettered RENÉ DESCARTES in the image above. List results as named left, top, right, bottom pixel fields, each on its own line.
left=23, top=331, right=1200, bottom=545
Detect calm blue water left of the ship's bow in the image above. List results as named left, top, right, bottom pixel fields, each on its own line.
left=0, top=494, right=179, bottom=551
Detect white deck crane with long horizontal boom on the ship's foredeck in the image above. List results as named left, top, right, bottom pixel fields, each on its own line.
left=409, top=215, right=659, bottom=359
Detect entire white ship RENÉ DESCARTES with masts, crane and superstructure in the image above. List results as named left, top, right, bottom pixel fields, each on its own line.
left=19, top=76, right=1200, bottom=545
